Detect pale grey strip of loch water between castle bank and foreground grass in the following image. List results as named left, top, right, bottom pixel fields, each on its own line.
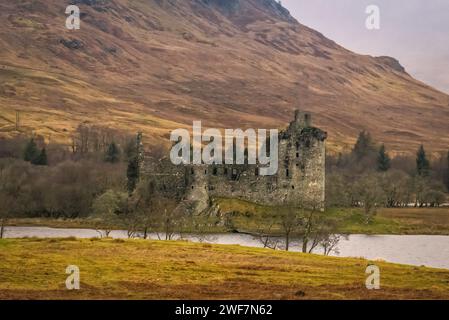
left=4, top=226, right=449, bottom=270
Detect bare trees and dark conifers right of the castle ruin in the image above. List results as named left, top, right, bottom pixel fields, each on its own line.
left=326, top=131, right=449, bottom=220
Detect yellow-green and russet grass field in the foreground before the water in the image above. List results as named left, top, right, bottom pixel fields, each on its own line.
left=0, top=239, right=449, bottom=299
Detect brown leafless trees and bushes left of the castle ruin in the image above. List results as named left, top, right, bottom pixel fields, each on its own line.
left=0, top=125, right=206, bottom=239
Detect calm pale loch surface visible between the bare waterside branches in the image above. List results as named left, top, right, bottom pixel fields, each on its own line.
left=5, top=227, right=449, bottom=269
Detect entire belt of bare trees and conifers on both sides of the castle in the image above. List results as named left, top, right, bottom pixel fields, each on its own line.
left=0, top=125, right=449, bottom=244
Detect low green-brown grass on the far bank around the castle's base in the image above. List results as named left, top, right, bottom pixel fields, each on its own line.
left=8, top=205, right=449, bottom=235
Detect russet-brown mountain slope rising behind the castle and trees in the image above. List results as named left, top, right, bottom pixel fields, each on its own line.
left=0, top=0, right=449, bottom=152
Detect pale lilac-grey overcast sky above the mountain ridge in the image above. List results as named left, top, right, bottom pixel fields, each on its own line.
left=282, top=0, right=449, bottom=93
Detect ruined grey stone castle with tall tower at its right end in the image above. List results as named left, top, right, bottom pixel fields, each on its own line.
left=145, top=111, right=327, bottom=212
